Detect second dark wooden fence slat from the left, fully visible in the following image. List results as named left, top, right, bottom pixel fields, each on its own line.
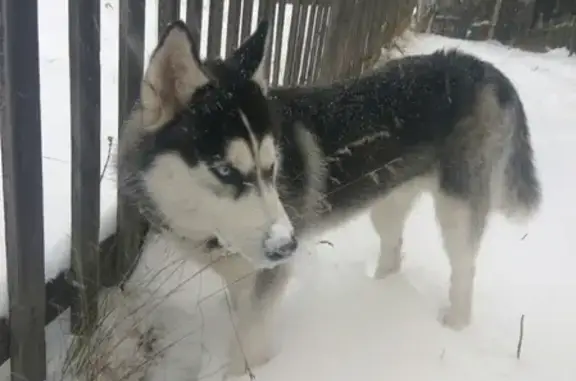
left=68, top=0, right=100, bottom=335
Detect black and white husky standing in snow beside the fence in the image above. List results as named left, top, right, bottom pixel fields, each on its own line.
left=70, top=22, right=540, bottom=381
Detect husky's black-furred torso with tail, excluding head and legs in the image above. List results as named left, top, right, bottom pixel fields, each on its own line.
left=272, top=50, right=540, bottom=229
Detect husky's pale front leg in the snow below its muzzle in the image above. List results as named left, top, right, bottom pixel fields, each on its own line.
left=214, top=256, right=290, bottom=376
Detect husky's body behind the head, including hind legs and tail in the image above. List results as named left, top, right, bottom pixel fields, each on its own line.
left=260, top=42, right=541, bottom=329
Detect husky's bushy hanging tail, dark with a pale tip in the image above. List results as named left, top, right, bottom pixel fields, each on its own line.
left=501, top=98, right=542, bottom=220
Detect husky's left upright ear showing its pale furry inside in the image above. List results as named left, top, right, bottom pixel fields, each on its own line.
left=140, top=21, right=208, bottom=113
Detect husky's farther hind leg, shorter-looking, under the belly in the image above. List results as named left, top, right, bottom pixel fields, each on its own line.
left=368, top=181, right=423, bottom=279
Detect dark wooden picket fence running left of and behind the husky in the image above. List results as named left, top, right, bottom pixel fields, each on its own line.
left=0, top=0, right=386, bottom=381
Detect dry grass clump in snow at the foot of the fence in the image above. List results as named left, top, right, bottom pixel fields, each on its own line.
left=61, top=238, right=252, bottom=381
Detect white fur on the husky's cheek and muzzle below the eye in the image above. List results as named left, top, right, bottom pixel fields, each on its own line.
left=143, top=153, right=291, bottom=267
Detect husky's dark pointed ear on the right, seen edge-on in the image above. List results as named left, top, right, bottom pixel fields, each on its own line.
left=227, top=20, right=271, bottom=93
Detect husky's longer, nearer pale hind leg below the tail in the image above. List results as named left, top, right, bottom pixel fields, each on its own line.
left=434, top=191, right=488, bottom=329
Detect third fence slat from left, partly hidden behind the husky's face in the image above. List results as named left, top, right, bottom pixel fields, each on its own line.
left=115, top=0, right=146, bottom=290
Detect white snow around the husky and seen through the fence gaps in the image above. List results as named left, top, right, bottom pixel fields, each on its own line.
left=0, top=0, right=576, bottom=381
